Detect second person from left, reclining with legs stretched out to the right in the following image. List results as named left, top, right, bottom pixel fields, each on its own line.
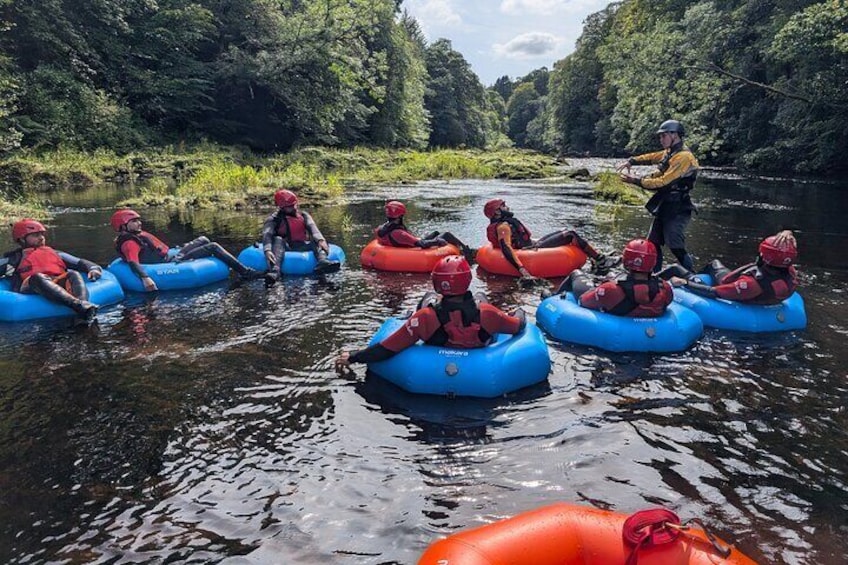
left=109, top=208, right=264, bottom=292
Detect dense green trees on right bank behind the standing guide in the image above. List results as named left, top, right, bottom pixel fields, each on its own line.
left=496, top=0, right=848, bottom=174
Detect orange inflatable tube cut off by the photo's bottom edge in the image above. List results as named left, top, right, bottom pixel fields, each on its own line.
left=418, top=503, right=756, bottom=565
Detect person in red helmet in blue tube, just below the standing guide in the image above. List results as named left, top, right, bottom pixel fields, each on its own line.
left=542, top=239, right=674, bottom=318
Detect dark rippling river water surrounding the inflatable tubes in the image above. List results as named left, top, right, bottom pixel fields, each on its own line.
left=0, top=162, right=848, bottom=565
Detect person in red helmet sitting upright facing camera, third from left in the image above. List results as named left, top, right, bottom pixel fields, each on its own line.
left=262, top=189, right=341, bottom=286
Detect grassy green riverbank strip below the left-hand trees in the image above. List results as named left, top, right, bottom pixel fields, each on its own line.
left=0, top=145, right=561, bottom=221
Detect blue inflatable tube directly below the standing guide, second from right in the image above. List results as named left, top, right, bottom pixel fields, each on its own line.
left=536, top=292, right=704, bottom=352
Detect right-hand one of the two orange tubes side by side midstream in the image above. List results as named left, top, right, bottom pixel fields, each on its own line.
left=477, top=243, right=586, bottom=278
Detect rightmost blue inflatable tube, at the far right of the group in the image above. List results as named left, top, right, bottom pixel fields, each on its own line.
left=674, top=275, right=807, bottom=333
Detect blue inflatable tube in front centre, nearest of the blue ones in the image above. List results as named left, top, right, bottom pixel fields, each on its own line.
left=368, top=318, right=551, bottom=398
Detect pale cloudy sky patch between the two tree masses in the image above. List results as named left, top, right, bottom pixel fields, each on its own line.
left=401, top=0, right=610, bottom=86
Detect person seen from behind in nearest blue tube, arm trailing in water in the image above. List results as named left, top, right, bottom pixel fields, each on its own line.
left=336, top=255, right=526, bottom=373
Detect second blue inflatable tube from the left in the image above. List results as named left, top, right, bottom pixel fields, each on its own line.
left=106, top=248, right=230, bottom=292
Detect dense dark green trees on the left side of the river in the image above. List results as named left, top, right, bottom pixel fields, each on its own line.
left=0, top=0, right=502, bottom=152
